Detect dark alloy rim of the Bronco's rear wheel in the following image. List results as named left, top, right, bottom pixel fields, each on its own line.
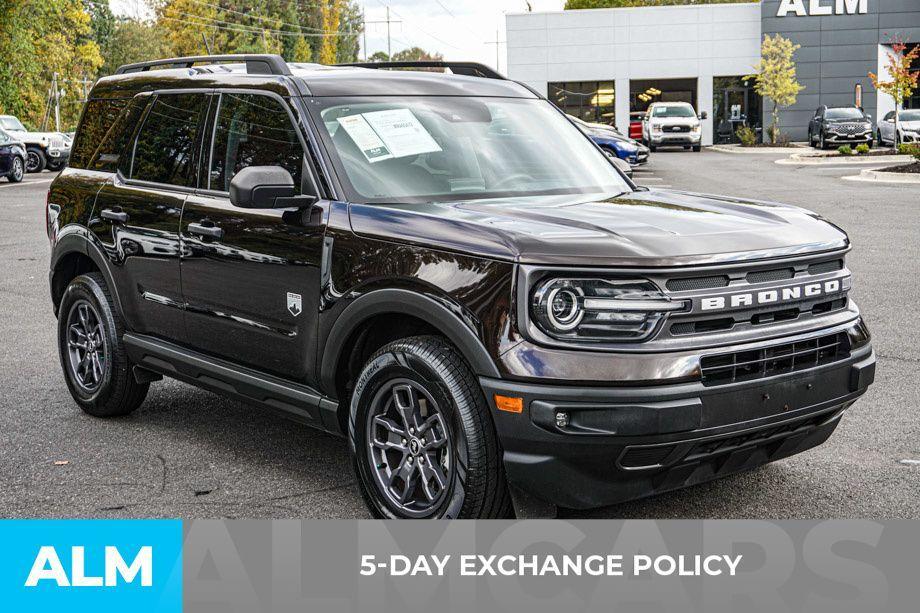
left=67, top=300, right=108, bottom=393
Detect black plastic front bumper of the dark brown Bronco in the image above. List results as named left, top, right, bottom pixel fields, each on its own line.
left=480, top=330, right=875, bottom=509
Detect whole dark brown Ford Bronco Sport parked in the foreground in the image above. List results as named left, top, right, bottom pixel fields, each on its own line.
left=47, top=55, right=875, bottom=518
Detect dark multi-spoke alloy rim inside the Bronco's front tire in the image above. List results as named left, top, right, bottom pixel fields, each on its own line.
left=365, top=379, right=454, bottom=517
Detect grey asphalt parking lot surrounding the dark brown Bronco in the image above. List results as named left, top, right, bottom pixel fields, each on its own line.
left=0, top=151, right=920, bottom=518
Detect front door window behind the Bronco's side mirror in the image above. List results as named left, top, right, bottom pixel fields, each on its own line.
left=210, top=94, right=303, bottom=191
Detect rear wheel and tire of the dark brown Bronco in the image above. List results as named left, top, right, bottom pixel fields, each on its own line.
left=58, top=273, right=150, bottom=417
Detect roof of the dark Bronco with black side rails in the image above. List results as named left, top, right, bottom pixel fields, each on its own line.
left=91, top=63, right=537, bottom=98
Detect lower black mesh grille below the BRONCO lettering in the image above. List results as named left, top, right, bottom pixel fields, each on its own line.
left=700, top=332, right=850, bottom=386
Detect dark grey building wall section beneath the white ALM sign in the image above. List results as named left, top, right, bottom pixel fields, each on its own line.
left=760, top=0, right=920, bottom=140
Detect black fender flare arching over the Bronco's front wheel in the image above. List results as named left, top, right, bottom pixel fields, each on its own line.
left=320, top=289, right=501, bottom=393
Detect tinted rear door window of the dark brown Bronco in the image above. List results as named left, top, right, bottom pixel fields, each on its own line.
left=131, top=94, right=207, bottom=186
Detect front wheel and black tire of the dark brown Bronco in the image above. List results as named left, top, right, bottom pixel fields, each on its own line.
left=348, top=336, right=511, bottom=519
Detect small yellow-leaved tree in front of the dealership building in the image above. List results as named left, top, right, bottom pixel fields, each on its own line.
left=747, top=34, right=805, bottom=144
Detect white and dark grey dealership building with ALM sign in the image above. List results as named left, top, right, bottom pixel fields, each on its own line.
left=505, top=0, right=920, bottom=144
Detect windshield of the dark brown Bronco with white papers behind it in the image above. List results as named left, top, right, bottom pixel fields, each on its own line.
left=312, top=96, right=630, bottom=203
